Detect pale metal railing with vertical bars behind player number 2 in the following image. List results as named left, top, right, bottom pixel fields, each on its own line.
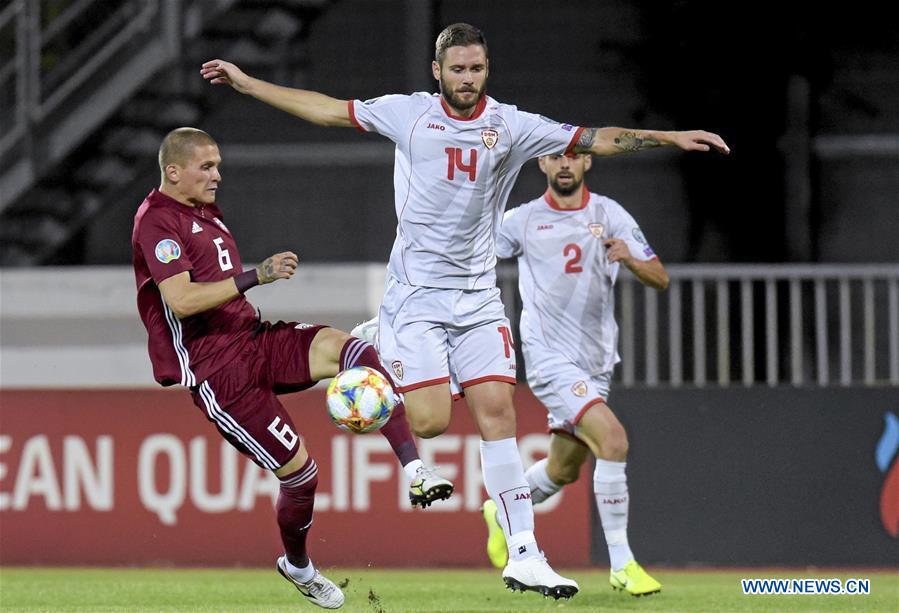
left=500, top=264, right=899, bottom=387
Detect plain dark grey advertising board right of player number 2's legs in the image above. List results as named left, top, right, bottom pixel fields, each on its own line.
left=608, top=387, right=899, bottom=567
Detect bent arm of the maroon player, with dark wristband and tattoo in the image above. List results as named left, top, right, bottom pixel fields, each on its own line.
left=159, top=251, right=297, bottom=319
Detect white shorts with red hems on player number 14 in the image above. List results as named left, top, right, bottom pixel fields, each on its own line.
left=378, top=277, right=515, bottom=392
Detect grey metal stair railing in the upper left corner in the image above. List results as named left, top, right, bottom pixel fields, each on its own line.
left=0, top=0, right=243, bottom=210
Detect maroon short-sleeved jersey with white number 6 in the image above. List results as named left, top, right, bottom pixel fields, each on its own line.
left=131, top=189, right=257, bottom=387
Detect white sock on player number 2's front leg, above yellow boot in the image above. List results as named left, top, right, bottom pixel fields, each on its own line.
left=593, top=458, right=634, bottom=570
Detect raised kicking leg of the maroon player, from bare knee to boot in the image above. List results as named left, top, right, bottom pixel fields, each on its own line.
left=309, top=328, right=453, bottom=508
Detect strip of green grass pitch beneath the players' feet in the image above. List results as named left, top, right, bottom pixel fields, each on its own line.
left=0, top=567, right=899, bottom=613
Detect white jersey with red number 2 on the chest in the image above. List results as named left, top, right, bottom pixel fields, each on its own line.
left=497, top=188, right=655, bottom=376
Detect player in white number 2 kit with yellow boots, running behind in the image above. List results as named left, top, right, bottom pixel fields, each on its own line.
left=483, top=154, right=668, bottom=596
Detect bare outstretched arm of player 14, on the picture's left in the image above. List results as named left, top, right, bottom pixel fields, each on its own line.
left=200, top=60, right=353, bottom=128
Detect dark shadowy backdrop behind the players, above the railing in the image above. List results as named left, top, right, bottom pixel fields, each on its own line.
left=4, top=0, right=899, bottom=264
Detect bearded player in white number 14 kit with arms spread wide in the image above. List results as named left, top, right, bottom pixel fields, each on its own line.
left=200, top=24, right=728, bottom=598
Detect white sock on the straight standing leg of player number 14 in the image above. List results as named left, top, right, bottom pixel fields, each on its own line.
left=481, top=438, right=540, bottom=560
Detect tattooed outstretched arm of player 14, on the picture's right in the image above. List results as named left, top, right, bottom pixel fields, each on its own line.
left=574, top=128, right=730, bottom=155
